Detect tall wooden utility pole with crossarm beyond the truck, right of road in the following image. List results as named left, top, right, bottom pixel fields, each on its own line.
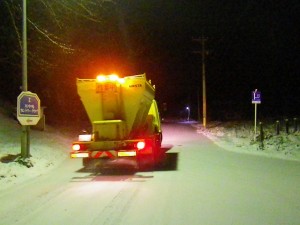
left=193, top=36, right=207, bottom=127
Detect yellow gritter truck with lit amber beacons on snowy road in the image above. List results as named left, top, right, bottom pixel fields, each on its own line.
left=70, top=74, right=165, bottom=169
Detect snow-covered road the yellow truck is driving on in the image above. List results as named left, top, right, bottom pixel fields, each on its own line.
left=0, top=123, right=300, bottom=225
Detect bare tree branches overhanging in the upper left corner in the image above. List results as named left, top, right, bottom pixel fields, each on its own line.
left=3, top=0, right=114, bottom=68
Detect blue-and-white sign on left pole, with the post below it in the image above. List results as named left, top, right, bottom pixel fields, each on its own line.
left=17, top=91, right=41, bottom=158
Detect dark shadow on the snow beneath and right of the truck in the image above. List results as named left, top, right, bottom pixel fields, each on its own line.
left=72, top=145, right=178, bottom=182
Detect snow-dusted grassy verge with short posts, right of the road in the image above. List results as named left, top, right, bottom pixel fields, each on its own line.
left=192, top=121, right=300, bottom=161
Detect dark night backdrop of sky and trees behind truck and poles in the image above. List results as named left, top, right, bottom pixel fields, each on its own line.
left=0, top=0, right=300, bottom=121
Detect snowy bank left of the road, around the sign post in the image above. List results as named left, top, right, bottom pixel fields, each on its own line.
left=0, top=110, right=71, bottom=191
